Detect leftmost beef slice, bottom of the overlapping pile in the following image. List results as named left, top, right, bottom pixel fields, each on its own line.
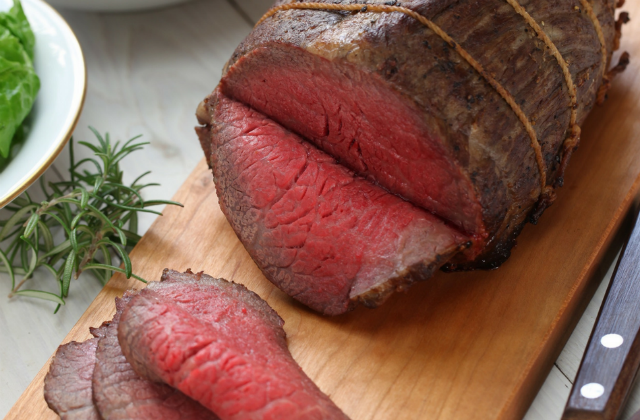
left=44, top=338, right=101, bottom=420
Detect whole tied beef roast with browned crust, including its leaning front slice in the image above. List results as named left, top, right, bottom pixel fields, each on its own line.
left=197, top=0, right=628, bottom=315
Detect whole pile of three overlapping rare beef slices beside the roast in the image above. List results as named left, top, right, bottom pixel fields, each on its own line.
left=44, top=269, right=348, bottom=420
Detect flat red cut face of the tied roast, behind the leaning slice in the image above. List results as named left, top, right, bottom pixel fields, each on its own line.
left=218, top=43, right=489, bottom=253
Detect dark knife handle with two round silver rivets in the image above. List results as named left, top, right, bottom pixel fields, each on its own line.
left=562, top=210, right=640, bottom=420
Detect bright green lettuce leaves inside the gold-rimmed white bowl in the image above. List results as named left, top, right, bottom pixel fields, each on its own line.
left=0, top=0, right=40, bottom=158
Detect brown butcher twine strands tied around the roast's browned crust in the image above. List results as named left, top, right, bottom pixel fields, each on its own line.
left=255, top=0, right=607, bottom=200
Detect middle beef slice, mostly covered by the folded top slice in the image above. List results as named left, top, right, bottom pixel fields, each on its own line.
left=92, top=293, right=218, bottom=420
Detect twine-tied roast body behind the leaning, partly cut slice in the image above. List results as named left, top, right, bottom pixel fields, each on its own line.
left=199, top=0, right=617, bottom=272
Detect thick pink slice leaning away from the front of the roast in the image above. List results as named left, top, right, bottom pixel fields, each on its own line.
left=201, top=91, right=469, bottom=315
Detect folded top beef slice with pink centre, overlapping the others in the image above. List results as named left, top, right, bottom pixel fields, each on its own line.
left=118, top=270, right=347, bottom=420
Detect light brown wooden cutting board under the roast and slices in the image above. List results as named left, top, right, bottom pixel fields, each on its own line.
left=6, top=7, right=640, bottom=420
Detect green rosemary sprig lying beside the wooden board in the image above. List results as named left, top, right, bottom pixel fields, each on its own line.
left=0, top=128, right=182, bottom=312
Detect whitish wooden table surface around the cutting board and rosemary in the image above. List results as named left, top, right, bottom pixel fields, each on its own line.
left=0, top=0, right=640, bottom=420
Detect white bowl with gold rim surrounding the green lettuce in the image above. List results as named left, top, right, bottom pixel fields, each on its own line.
left=0, top=0, right=87, bottom=208
